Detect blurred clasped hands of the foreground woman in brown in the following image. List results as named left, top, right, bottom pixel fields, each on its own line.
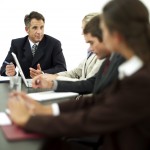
left=8, top=92, right=52, bottom=126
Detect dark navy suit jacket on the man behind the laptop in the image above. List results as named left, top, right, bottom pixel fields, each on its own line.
left=1, top=35, right=66, bottom=78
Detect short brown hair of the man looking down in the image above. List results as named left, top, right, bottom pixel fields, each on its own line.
left=83, top=15, right=102, bottom=42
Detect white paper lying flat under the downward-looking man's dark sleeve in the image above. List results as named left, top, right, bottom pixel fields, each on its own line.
left=28, top=91, right=79, bottom=101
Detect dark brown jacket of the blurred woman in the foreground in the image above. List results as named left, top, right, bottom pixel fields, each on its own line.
left=25, top=66, right=150, bottom=150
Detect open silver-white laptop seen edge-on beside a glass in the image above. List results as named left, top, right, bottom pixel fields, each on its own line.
left=11, top=52, right=32, bottom=87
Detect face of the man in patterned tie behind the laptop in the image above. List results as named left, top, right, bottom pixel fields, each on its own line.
left=25, top=19, right=44, bottom=43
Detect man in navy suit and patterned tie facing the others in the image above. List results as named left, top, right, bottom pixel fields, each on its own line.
left=1, top=11, right=66, bottom=78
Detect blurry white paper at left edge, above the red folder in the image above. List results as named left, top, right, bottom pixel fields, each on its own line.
left=0, top=112, right=11, bottom=125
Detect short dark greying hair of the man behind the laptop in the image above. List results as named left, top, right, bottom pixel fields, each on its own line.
left=24, top=11, right=45, bottom=27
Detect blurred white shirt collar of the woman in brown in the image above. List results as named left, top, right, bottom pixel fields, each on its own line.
left=118, top=56, right=143, bottom=80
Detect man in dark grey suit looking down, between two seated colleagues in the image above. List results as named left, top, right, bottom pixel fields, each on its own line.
left=33, top=16, right=124, bottom=94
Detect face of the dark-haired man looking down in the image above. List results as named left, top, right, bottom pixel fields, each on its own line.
left=84, top=33, right=110, bottom=59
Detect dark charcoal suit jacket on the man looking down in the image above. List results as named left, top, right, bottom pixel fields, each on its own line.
left=55, top=54, right=125, bottom=94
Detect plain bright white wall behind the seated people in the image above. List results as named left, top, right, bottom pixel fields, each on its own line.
left=0, top=0, right=150, bottom=69
